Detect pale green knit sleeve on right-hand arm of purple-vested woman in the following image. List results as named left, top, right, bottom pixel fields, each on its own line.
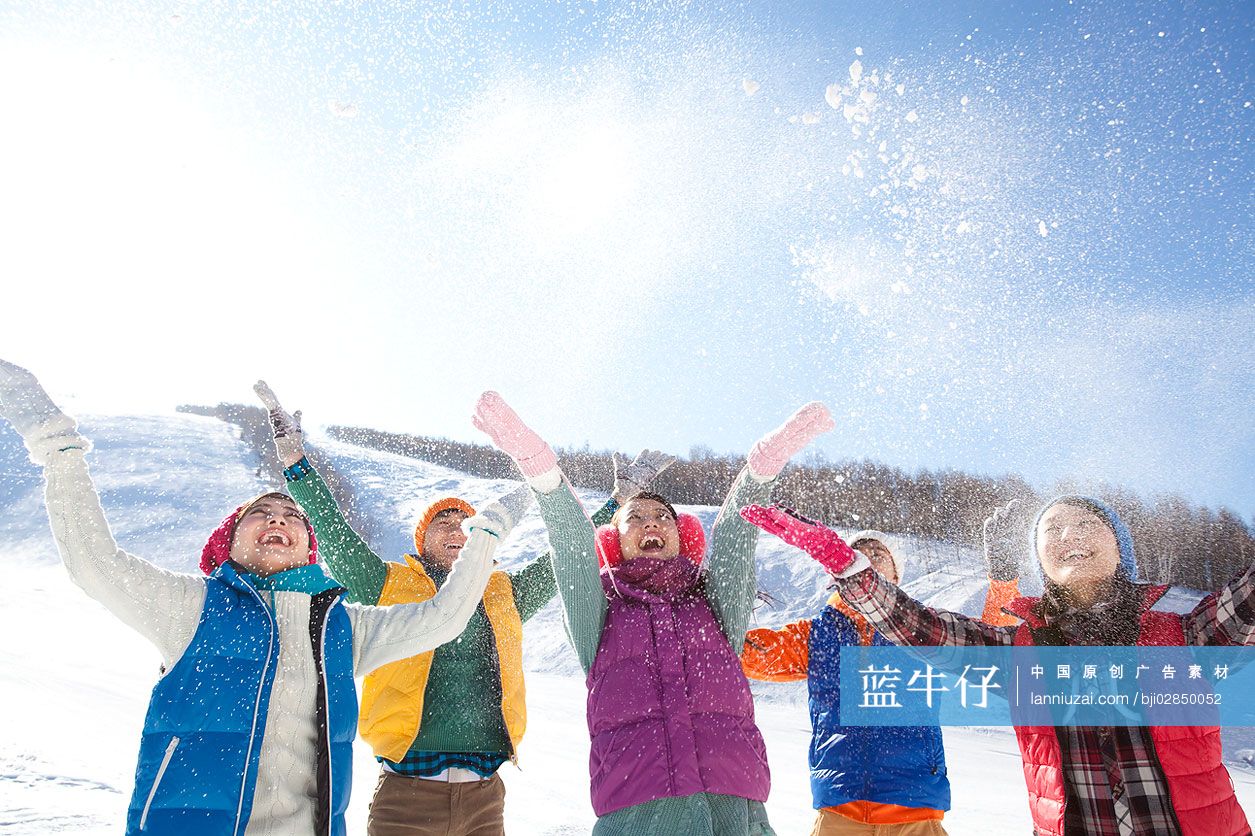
left=705, top=468, right=774, bottom=654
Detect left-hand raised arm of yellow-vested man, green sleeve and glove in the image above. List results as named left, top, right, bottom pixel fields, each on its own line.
left=254, top=380, right=388, bottom=604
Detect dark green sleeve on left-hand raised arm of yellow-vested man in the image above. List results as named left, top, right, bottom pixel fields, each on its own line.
left=287, top=459, right=388, bottom=605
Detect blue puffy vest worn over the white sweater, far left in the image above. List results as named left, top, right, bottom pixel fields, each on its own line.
left=127, top=561, right=358, bottom=836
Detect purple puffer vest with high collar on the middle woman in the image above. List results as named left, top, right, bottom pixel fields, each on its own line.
left=587, top=557, right=771, bottom=816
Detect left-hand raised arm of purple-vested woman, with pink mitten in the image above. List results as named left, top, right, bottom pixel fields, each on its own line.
left=472, top=392, right=607, bottom=672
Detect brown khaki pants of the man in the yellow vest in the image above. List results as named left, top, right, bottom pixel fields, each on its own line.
left=366, top=769, right=506, bottom=836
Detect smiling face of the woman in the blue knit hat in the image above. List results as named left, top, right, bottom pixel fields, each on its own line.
left=1037, top=502, right=1119, bottom=592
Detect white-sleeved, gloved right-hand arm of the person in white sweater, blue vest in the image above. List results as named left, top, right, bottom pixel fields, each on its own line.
left=348, top=486, right=532, bottom=677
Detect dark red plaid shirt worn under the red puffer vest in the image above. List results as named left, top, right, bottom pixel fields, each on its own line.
left=841, top=566, right=1255, bottom=836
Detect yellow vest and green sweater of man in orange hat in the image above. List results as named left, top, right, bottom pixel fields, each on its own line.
left=285, top=461, right=617, bottom=764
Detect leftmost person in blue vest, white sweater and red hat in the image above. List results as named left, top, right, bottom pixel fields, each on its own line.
left=0, top=360, right=531, bottom=836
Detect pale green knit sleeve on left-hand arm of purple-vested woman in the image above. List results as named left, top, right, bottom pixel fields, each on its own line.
left=536, top=480, right=607, bottom=673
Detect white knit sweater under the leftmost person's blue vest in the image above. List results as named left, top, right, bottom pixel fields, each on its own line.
left=44, top=448, right=511, bottom=836
